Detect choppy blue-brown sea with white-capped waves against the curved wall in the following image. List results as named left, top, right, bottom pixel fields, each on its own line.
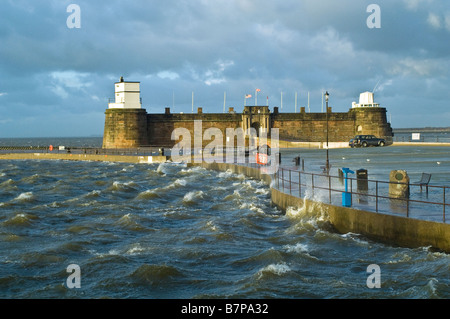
left=0, top=141, right=450, bottom=299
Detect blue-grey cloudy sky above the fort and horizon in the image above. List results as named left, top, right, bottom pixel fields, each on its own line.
left=0, top=0, right=450, bottom=137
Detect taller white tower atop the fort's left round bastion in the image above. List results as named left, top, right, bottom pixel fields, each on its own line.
left=108, top=77, right=142, bottom=109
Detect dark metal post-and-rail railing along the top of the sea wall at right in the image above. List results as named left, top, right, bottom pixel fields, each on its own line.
left=274, top=167, right=450, bottom=223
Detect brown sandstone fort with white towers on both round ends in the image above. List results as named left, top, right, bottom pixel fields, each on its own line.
left=103, top=77, right=393, bottom=148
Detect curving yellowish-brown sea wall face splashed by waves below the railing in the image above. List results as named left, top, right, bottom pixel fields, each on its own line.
left=200, top=163, right=450, bottom=253
